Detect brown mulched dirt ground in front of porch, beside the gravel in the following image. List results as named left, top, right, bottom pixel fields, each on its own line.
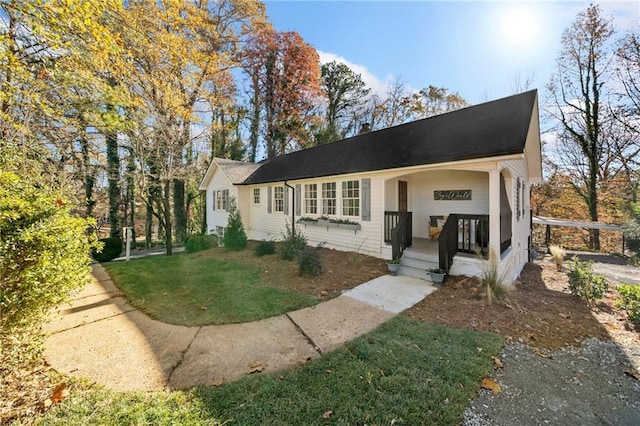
left=406, top=262, right=640, bottom=349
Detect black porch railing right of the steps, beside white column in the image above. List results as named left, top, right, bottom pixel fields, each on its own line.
left=438, top=214, right=489, bottom=272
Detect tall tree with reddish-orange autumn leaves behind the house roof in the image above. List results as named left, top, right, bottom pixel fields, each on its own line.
left=244, top=28, right=320, bottom=159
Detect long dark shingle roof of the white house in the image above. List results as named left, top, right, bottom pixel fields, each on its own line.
left=245, top=90, right=537, bottom=184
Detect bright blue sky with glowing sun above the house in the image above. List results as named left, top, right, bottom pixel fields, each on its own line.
left=265, top=0, right=640, bottom=104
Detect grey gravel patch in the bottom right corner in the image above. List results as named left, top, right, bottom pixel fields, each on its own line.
left=463, top=339, right=640, bottom=426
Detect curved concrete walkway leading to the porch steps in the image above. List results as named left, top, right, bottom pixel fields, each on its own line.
left=45, top=264, right=436, bottom=390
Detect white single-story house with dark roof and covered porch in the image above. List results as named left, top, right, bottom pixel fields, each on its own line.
left=200, top=90, right=542, bottom=279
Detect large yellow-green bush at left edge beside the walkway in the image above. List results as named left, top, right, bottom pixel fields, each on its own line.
left=0, top=171, right=93, bottom=370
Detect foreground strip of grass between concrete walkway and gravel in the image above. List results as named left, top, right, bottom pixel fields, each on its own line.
left=37, top=316, right=504, bottom=426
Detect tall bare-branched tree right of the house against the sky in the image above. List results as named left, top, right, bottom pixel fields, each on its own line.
left=548, top=5, right=613, bottom=250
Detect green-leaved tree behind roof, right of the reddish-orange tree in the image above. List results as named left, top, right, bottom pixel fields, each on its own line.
left=318, top=61, right=371, bottom=143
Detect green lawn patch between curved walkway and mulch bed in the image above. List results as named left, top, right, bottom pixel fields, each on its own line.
left=104, top=253, right=318, bottom=326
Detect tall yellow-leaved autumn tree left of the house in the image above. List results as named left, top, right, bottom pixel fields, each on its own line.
left=113, top=0, right=264, bottom=255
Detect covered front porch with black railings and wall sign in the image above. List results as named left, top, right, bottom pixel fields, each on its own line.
left=384, top=166, right=512, bottom=275
